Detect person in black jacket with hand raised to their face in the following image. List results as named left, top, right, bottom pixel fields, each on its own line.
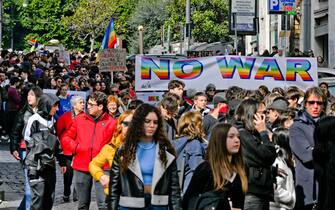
left=235, top=99, right=277, bottom=210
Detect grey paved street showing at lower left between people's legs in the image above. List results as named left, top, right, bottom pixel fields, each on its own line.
left=0, top=144, right=98, bottom=210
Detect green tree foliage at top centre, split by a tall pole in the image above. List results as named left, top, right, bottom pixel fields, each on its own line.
left=166, top=0, right=229, bottom=43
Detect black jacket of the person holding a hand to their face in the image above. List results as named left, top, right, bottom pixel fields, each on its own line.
left=237, top=123, right=277, bottom=200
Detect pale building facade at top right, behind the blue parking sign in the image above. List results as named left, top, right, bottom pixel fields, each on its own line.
left=245, top=0, right=335, bottom=68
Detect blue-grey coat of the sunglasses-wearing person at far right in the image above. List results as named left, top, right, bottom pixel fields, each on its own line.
left=289, top=111, right=318, bottom=207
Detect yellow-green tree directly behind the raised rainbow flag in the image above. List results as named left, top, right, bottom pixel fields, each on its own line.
left=62, top=0, right=135, bottom=51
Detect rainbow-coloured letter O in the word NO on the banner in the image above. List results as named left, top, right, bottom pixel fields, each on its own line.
left=173, top=60, right=204, bottom=79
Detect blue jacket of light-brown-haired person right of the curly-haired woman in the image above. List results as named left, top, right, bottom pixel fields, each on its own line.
left=172, top=136, right=207, bottom=193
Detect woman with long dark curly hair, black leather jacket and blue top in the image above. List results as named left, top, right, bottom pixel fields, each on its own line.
left=109, top=104, right=181, bottom=210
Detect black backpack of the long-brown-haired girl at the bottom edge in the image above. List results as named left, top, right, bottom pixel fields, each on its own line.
left=187, top=192, right=231, bottom=210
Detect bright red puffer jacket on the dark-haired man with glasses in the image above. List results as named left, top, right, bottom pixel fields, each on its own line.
left=62, top=113, right=116, bottom=171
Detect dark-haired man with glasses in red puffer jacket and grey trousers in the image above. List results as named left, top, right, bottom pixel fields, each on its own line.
left=62, top=92, right=116, bottom=210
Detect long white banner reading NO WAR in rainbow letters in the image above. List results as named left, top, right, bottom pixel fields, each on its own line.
left=135, top=55, right=318, bottom=91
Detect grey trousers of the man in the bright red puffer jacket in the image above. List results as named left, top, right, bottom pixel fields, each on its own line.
left=73, top=170, right=107, bottom=210
